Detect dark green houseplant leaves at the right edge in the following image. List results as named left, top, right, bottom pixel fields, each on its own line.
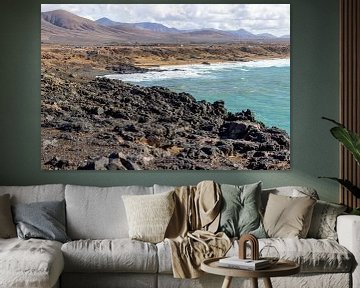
left=321, top=117, right=360, bottom=215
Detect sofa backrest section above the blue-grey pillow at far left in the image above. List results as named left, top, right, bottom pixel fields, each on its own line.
left=0, top=184, right=65, bottom=204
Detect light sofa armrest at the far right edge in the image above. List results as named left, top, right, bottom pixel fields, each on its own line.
left=336, top=215, right=360, bottom=287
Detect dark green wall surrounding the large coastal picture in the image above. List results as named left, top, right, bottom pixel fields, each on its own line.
left=0, top=0, right=339, bottom=201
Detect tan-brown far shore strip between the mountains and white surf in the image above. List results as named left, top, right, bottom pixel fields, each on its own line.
left=41, top=42, right=290, bottom=78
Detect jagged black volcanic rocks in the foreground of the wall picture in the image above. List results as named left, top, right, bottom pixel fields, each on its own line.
left=41, top=65, right=290, bottom=170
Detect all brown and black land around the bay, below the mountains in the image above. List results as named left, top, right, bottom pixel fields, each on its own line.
left=41, top=44, right=290, bottom=170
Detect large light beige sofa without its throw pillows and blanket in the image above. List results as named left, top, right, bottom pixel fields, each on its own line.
left=0, top=184, right=360, bottom=288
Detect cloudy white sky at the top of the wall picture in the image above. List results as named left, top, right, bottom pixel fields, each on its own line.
left=41, top=4, right=290, bottom=36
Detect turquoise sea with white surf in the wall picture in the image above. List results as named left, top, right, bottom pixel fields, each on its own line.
left=106, top=59, right=290, bottom=134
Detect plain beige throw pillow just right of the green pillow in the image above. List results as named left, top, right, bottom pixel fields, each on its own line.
left=264, top=194, right=316, bottom=238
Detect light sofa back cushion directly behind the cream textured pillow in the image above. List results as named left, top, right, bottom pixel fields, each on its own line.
left=65, top=185, right=153, bottom=240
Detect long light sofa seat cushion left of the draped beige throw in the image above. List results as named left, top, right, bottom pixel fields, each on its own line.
left=61, top=239, right=158, bottom=273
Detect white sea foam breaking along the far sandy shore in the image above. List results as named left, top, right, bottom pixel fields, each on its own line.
left=104, top=58, right=290, bottom=82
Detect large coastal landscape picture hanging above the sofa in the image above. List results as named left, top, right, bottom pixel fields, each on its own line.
left=41, top=4, right=291, bottom=170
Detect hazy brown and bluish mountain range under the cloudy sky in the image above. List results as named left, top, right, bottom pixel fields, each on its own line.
left=41, top=10, right=286, bottom=45
